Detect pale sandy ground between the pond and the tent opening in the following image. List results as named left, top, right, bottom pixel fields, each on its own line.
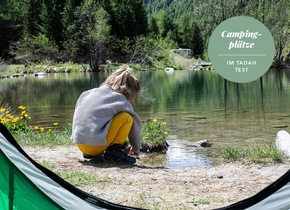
left=24, top=146, right=290, bottom=209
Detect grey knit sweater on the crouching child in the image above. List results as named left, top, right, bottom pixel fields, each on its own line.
left=72, top=85, right=142, bottom=149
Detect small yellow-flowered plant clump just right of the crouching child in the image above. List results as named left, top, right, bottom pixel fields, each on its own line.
left=142, top=118, right=168, bottom=143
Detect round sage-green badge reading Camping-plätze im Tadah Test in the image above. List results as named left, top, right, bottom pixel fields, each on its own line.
left=208, top=16, right=275, bottom=83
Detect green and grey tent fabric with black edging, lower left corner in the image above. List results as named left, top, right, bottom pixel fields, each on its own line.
left=0, top=123, right=144, bottom=210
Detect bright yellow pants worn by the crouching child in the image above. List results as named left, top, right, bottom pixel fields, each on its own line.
left=78, top=112, right=133, bottom=156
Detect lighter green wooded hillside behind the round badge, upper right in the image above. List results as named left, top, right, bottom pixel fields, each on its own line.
left=145, top=0, right=290, bottom=66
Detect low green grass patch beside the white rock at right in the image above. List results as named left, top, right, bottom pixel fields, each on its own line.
left=221, top=145, right=286, bottom=163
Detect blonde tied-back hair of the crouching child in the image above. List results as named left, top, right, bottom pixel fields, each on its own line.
left=104, top=67, right=141, bottom=102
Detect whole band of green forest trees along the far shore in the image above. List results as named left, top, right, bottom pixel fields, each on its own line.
left=0, top=0, right=290, bottom=71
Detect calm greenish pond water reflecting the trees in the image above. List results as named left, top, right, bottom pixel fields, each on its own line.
left=0, top=70, right=290, bottom=168
